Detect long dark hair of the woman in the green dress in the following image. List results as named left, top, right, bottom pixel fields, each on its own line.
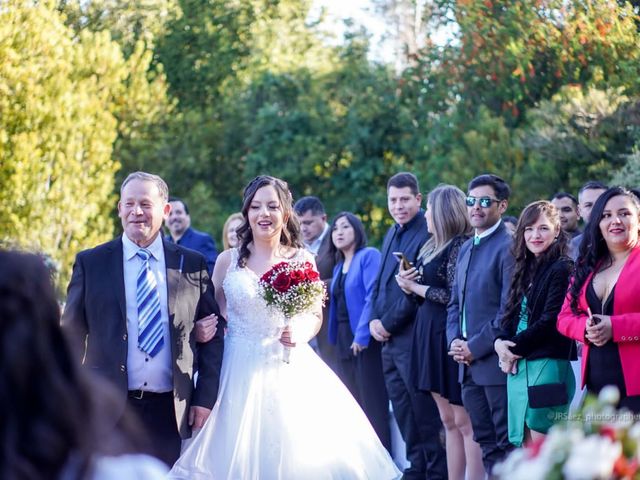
left=502, top=200, right=568, bottom=328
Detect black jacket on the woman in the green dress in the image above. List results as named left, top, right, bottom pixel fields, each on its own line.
left=502, top=257, right=576, bottom=360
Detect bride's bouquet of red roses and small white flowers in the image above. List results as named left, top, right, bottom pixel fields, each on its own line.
left=259, top=262, right=325, bottom=363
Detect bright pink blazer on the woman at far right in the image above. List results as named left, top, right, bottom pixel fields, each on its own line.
left=557, top=248, right=640, bottom=395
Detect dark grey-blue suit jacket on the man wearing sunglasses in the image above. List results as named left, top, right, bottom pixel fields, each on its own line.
left=447, top=222, right=514, bottom=386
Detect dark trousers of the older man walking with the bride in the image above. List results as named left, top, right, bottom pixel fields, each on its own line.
left=127, top=392, right=182, bottom=467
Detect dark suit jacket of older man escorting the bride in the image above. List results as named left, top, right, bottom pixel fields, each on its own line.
left=62, top=238, right=224, bottom=438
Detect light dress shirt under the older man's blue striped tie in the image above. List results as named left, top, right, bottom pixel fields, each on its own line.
left=122, top=235, right=173, bottom=392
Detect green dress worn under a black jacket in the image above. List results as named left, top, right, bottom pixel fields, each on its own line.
left=507, top=297, right=576, bottom=447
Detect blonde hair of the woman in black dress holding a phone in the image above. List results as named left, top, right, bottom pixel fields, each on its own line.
left=418, top=185, right=471, bottom=264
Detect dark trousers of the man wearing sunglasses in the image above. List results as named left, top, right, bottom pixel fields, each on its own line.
left=462, top=372, right=513, bottom=475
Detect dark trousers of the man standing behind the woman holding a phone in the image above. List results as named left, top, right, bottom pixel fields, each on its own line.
left=382, top=342, right=447, bottom=480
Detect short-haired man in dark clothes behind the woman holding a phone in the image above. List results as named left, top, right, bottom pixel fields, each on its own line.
left=369, top=172, right=447, bottom=480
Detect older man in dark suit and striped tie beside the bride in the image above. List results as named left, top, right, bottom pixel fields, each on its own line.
left=62, top=172, right=223, bottom=465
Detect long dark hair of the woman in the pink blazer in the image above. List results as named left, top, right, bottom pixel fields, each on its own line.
left=569, top=187, right=640, bottom=315
